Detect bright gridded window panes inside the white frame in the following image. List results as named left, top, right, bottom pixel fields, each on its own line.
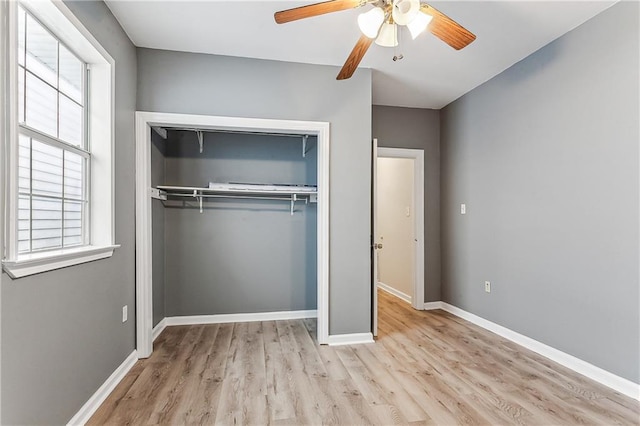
left=18, top=7, right=91, bottom=253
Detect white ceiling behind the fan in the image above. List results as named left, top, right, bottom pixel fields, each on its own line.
left=106, top=0, right=616, bottom=109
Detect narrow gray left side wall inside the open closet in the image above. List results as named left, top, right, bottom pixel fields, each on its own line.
left=151, top=131, right=167, bottom=327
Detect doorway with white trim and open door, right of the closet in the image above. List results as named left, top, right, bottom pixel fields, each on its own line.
left=372, top=143, right=424, bottom=335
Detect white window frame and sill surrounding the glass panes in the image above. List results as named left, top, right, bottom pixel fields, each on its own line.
left=0, top=0, right=119, bottom=278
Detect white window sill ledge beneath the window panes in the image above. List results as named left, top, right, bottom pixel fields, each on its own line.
left=2, top=245, right=120, bottom=278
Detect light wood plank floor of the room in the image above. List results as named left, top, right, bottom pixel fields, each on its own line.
left=89, top=292, right=640, bottom=425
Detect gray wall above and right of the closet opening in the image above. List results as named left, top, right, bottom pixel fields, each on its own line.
left=137, top=49, right=371, bottom=334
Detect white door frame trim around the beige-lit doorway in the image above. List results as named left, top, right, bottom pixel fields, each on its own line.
left=374, top=147, right=424, bottom=310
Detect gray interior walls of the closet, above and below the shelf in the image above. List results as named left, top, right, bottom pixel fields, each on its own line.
left=151, top=130, right=317, bottom=325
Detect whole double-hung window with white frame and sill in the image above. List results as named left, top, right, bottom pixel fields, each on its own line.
left=2, top=0, right=117, bottom=278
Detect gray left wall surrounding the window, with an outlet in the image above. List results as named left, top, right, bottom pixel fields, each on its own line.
left=1, top=2, right=136, bottom=425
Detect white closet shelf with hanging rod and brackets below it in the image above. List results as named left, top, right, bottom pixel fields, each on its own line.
left=151, top=183, right=318, bottom=215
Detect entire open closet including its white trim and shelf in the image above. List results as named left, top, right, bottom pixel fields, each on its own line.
left=136, top=112, right=329, bottom=358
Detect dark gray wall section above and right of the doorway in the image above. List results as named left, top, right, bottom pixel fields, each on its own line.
left=372, top=105, right=441, bottom=302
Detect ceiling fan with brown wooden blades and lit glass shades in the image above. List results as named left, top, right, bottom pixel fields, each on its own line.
left=274, top=0, right=476, bottom=80
